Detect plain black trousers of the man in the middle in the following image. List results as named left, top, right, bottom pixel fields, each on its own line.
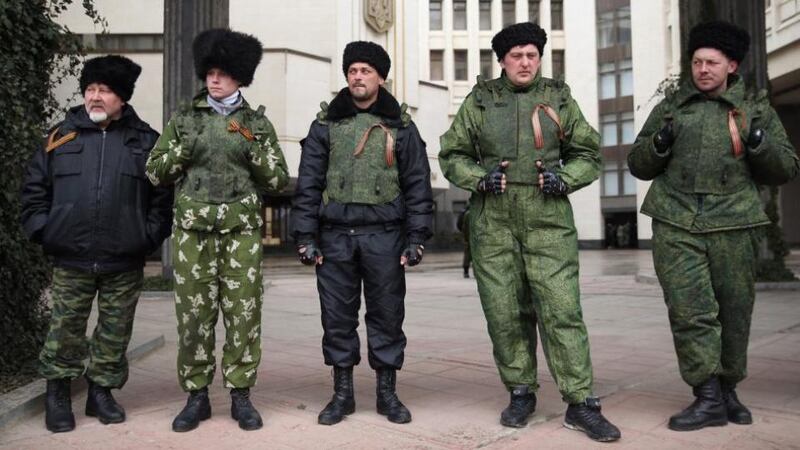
left=317, top=227, right=406, bottom=370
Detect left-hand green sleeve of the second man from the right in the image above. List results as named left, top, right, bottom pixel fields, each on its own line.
left=439, top=95, right=488, bottom=192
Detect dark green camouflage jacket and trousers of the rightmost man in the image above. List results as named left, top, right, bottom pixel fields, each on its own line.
left=628, top=75, right=799, bottom=386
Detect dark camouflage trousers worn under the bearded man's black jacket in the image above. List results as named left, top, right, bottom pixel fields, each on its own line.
left=39, top=267, right=143, bottom=388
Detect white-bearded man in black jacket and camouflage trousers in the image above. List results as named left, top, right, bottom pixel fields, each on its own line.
left=22, top=55, right=172, bottom=433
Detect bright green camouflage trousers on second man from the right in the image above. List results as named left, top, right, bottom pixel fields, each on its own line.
left=469, top=185, right=592, bottom=403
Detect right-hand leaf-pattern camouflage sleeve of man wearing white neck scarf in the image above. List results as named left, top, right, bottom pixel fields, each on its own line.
left=250, top=117, right=289, bottom=193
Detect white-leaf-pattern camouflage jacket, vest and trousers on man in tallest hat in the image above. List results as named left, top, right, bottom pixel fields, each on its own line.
left=147, top=90, right=288, bottom=391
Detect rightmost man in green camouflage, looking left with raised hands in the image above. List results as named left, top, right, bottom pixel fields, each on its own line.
left=628, top=22, right=800, bottom=431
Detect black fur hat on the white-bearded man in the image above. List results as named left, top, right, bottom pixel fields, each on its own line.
left=78, top=55, right=142, bottom=102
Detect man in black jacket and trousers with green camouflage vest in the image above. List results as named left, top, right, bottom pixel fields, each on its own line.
left=292, top=41, right=433, bottom=425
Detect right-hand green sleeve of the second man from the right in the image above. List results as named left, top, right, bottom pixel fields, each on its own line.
left=558, top=90, right=602, bottom=192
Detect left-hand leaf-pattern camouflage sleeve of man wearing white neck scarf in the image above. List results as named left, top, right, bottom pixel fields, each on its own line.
left=145, top=116, right=191, bottom=186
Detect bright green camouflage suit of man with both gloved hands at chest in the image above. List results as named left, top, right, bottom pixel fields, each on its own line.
left=439, top=74, right=600, bottom=403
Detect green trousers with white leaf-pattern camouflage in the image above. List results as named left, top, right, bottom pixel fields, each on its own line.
left=172, top=228, right=263, bottom=391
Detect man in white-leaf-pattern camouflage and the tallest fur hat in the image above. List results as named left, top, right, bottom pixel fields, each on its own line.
left=147, top=29, right=289, bottom=432
